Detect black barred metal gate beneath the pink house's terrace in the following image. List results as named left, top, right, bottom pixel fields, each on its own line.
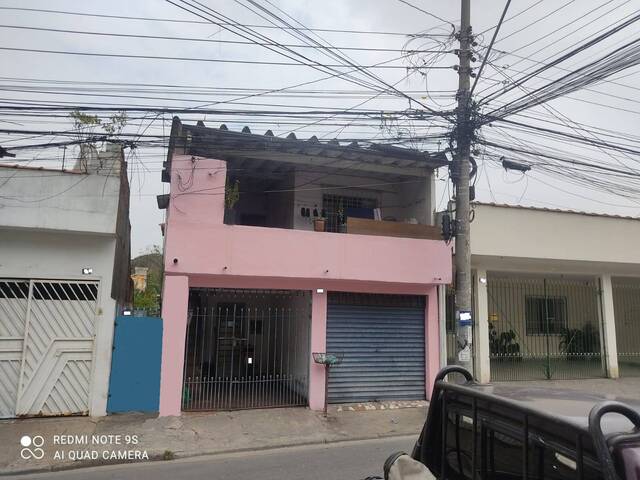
left=182, top=289, right=311, bottom=411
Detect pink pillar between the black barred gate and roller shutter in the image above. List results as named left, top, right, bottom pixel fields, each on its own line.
left=309, top=290, right=327, bottom=410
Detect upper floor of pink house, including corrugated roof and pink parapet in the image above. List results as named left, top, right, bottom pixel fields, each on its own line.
left=159, top=120, right=451, bottom=285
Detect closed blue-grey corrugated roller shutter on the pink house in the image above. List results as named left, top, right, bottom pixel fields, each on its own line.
left=327, top=293, right=425, bottom=403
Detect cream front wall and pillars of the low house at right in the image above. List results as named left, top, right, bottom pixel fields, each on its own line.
left=464, top=203, right=640, bottom=382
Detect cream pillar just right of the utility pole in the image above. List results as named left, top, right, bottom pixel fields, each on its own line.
left=473, top=269, right=491, bottom=383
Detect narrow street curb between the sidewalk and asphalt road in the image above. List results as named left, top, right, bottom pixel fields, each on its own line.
left=0, top=431, right=420, bottom=477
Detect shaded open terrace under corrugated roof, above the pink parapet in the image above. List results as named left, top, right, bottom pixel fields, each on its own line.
left=164, top=119, right=447, bottom=239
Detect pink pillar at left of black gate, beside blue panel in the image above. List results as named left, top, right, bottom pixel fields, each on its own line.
left=160, top=275, right=189, bottom=417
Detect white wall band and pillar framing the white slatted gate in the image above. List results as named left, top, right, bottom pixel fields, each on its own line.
left=0, top=227, right=116, bottom=416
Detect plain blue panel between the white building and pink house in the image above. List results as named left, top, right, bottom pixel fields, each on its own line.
left=107, top=316, right=162, bottom=413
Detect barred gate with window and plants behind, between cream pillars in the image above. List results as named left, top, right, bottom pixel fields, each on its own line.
left=487, top=274, right=604, bottom=381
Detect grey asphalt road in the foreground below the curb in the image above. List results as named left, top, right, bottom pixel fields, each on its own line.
left=2, top=437, right=430, bottom=480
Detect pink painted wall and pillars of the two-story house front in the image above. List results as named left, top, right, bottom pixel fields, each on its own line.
left=160, top=156, right=451, bottom=415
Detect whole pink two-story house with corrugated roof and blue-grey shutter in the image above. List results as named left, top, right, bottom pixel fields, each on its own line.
left=158, top=118, right=451, bottom=415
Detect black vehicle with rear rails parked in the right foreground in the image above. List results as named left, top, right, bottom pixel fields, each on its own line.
left=385, top=367, right=640, bottom=480
